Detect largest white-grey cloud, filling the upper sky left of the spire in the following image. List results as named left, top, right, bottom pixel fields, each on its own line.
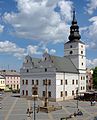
left=4, top=0, right=73, bottom=43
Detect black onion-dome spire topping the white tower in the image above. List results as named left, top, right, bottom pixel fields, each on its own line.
left=69, top=9, right=81, bottom=42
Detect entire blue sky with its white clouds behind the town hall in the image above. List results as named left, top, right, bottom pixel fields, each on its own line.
left=0, top=0, right=97, bottom=70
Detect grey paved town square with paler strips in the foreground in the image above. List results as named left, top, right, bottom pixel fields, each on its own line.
left=0, top=93, right=97, bottom=120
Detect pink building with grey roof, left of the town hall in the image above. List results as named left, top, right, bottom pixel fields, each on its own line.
left=0, top=70, right=20, bottom=90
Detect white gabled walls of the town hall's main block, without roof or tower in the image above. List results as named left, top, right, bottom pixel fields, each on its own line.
left=20, top=51, right=85, bottom=101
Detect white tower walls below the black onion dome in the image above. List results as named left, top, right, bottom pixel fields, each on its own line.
left=64, top=42, right=86, bottom=93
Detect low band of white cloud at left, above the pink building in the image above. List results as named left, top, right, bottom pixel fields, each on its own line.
left=0, top=41, right=56, bottom=59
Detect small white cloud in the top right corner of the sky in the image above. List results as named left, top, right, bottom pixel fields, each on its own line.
left=86, top=0, right=97, bottom=14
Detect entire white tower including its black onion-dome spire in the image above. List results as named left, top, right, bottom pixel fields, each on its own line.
left=64, top=10, right=86, bottom=92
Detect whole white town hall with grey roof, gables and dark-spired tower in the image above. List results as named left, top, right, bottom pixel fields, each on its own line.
left=20, top=11, right=86, bottom=101
